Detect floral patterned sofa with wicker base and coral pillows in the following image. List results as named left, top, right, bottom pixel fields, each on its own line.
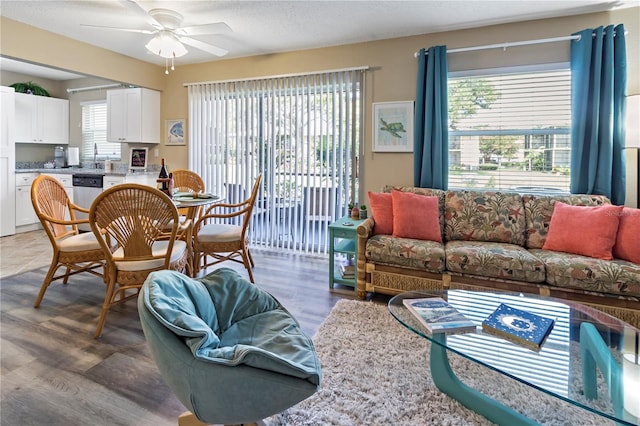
left=357, top=186, right=640, bottom=327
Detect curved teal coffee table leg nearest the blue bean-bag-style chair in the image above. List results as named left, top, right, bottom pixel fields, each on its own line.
left=430, top=334, right=538, bottom=426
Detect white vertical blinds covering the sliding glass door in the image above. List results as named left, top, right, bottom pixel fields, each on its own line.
left=188, top=69, right=364, bottom=253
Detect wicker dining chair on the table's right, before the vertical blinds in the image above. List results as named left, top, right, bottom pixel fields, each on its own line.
left=193, top=175, right=262, bottom=283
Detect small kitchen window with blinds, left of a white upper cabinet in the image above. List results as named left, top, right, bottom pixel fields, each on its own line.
left=81, top=101, right=122, bottom=163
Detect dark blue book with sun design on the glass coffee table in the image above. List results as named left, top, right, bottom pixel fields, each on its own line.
left=482, top=303, right=555, bottom=352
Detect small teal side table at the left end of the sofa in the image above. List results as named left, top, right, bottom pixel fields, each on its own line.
left=329, top=216, right=364, bottom=290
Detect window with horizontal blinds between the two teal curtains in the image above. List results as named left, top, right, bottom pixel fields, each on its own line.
left=448, top=66, right=571, bottom=192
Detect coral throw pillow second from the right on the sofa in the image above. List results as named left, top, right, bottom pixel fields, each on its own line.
left=542, top=201, right=624, bottom=260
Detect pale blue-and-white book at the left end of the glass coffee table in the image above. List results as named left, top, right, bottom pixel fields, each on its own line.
left=402, top=297, right=476, bottom=334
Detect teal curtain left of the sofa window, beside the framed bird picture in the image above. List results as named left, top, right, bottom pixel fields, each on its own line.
left=413, top=46, right=449, bottom=189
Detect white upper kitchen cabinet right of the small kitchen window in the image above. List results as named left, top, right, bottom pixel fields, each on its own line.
left=107, top=88, right=160, bottom=143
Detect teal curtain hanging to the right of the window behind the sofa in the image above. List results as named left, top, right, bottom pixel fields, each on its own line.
left=571, top=24, right=627, bottom=205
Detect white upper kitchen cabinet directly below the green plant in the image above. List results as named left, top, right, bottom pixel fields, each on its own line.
left=15, top=93, right=69, bottom=145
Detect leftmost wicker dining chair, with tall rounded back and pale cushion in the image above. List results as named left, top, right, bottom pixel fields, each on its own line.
left=31, top=175, right=105, bottom=308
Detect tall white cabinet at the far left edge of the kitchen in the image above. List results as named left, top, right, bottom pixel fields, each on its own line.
left=0, top=86, right=16, bottom=237
